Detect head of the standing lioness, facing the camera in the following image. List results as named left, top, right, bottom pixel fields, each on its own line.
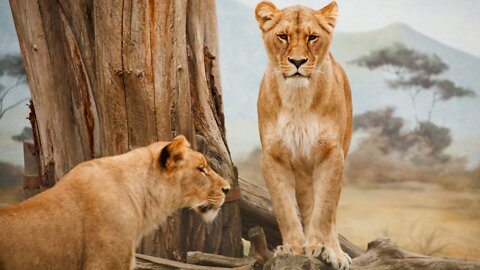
left=255, top=1, right=338, bottom=84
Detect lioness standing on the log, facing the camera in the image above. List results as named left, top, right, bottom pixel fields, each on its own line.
left=255, top=2, right=352, bottom=269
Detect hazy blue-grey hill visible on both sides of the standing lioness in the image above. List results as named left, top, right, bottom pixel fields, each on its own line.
left=217, top=0, right=480, bottom=165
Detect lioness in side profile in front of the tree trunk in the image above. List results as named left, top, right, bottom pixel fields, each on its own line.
left=0, top=136, right=230, bottom=270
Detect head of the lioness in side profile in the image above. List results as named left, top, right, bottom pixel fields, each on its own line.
left=158, top=135, right=230, bottom=222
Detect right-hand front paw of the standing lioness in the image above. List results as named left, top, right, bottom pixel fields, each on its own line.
left=305, top=244, right=352, bottom=270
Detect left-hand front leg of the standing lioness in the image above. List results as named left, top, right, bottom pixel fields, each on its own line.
left=262, top=151, right=305, bottom=256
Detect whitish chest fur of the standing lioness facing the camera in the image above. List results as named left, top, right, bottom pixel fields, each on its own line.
left=277, top=77, right=321, bottom=158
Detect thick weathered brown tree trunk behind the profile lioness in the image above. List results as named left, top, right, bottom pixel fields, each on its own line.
left=10, top=0, right=243, bottom=260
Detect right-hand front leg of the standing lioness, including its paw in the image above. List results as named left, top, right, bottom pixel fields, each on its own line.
left=305, top=148, right=351, bottom=270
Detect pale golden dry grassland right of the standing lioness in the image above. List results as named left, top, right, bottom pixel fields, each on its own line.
left=337, top=182, right=480, bottom=259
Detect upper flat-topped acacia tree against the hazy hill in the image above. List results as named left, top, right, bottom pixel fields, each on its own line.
left=352, top=43, right=475, bottom=126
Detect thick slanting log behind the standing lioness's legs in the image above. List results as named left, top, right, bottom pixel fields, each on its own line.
left=238, top=177, right=364, bottom=258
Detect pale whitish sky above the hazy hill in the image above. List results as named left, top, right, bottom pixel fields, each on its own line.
left=235, top=0, right=480, bottom=57
